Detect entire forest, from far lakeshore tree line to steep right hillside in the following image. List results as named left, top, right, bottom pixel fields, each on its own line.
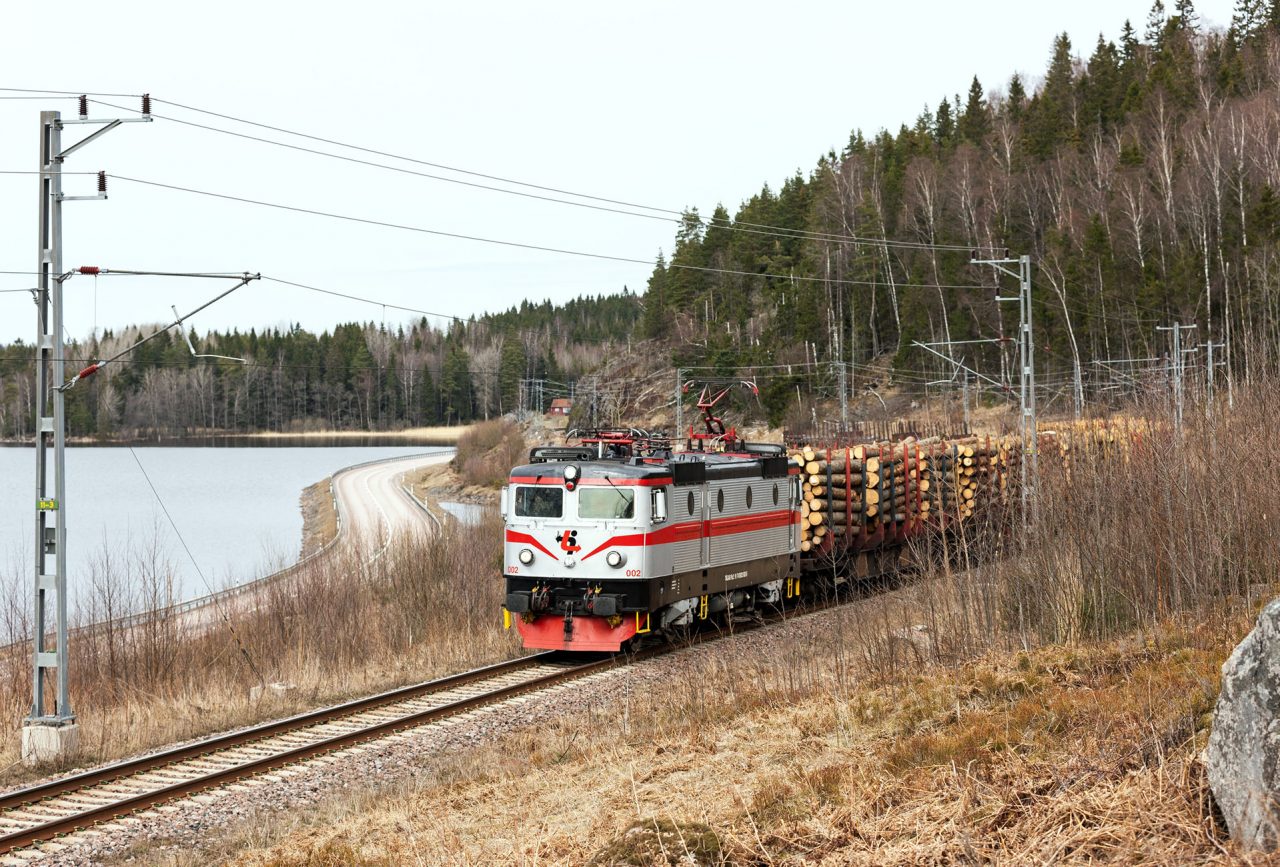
left=0, top=0, right=1280, bottom=437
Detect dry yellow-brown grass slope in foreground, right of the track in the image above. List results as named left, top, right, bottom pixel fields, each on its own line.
left=154, top=603, right=1238, bottom=867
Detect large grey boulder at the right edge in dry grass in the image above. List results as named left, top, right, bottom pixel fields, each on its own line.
left=1206, top=599, right=1280, bottom=850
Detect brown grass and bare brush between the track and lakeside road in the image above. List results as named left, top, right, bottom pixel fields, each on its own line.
left=0, top=514, right=520, bottom=785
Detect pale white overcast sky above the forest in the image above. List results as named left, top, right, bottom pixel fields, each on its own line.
left=0, top=0, right=1233, bottom=342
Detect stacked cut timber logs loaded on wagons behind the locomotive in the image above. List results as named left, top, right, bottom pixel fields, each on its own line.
left=791, top=437, right=1019, bottom=551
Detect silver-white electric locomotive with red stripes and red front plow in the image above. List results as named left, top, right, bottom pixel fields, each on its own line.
left=502, top=425, right=801, bottom=651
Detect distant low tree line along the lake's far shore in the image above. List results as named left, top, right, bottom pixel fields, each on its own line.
left=0, top=291, right=640, bottom=439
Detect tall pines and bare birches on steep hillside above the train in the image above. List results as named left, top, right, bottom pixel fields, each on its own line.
left=643, top=0, right=1280, bottom=420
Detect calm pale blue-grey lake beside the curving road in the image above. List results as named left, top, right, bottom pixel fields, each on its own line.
left=0, top=441, right=448, bottom=606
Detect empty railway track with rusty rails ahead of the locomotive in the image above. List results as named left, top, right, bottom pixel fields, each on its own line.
left=0, top=652, right=618, bottom=853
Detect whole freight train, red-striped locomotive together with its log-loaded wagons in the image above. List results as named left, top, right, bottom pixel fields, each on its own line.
left=502, top=383, right=1020, bottom=652
